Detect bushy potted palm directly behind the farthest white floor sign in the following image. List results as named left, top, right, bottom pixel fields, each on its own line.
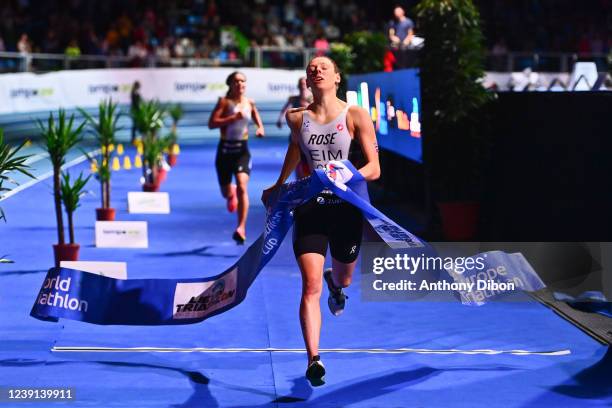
left=132, top=101, right=166, bottom=191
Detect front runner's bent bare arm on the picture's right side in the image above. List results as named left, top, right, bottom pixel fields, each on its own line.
left=349, top=106, right=380, bottom=181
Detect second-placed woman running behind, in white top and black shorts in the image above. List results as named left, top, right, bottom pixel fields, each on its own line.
left=208, top=71, right=265, bottom=244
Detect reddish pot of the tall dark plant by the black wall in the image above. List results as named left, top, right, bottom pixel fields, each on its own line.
left=438, top=201, right=480, bottom=241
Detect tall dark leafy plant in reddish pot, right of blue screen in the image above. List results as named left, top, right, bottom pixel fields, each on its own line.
left=416, top=0, right=492, bottom=240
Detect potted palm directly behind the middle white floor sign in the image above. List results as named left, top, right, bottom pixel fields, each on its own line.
left=79, top=99, right=121, bottom=221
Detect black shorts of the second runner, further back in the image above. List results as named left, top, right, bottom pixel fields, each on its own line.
left=215, top=140, right=251, bottom=186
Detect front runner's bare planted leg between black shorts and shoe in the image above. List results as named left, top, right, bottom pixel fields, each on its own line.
left=297, top=253, right=325, bottom=362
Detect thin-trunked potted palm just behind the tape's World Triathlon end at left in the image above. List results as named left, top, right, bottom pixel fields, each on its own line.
left=37, top=109, right=86, bottom=266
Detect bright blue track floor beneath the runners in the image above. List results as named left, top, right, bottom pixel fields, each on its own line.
left=0, top=139, right=612, bottom=407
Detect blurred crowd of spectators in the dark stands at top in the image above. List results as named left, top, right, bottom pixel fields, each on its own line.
left=0, top=0, right=612, bottom=64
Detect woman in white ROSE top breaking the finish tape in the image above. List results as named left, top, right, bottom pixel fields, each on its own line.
left=262, top=57, right=380, bottom=386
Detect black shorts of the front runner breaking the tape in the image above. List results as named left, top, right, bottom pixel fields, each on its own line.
left=293, top=192, right=363, bottom=263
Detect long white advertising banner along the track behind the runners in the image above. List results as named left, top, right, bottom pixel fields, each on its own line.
left=0, top=68, right=304, bottom=114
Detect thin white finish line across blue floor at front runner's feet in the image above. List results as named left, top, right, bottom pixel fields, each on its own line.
left=51, top=346, right=571, bottom=356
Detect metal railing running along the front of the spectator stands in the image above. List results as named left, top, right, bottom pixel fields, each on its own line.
left=0, top=46, right=609, bottom=72
